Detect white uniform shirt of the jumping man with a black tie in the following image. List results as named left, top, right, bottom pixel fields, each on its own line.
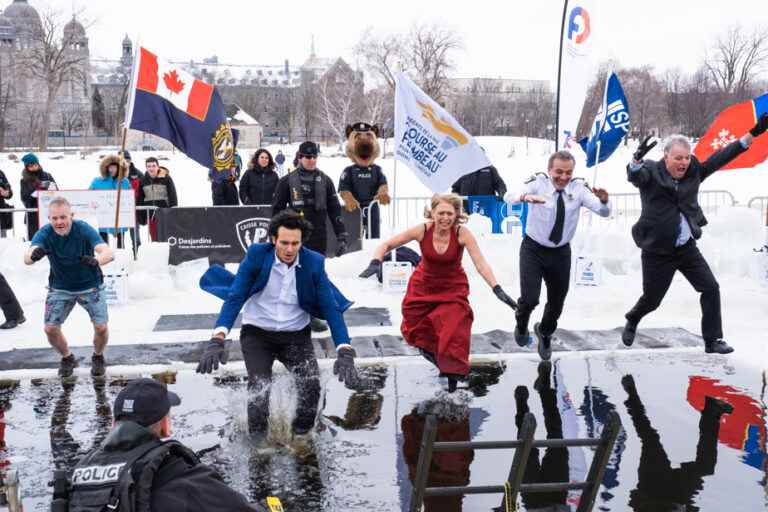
left=504, top=173, right=611, bottom=247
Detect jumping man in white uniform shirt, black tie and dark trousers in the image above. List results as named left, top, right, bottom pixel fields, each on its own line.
left=504, top=151, right=611, bottom=360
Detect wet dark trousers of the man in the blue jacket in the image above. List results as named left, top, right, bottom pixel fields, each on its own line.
left=240, top=325, right=320, bottom=433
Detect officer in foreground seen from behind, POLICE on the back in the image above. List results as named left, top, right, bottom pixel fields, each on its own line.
left=58, top=379, right=264, bottom=512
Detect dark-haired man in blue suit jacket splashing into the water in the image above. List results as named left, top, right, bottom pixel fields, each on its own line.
left=197, top=210, right=358, bottom=435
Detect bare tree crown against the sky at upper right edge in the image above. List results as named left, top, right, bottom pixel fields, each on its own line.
left=704, top=25, right=768, bottom=100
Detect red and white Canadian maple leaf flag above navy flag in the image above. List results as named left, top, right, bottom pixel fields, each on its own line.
left=136, top=47, right=213, bottom=121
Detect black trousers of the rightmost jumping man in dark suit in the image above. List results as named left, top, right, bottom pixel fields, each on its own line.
left=626, top=240, right=723, bottom=341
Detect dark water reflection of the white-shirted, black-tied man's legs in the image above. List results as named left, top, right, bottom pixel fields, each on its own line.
left=515, top=361, right=569, bottom=510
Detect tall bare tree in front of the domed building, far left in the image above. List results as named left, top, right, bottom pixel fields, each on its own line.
left=20, top=10, right=87, bottom=150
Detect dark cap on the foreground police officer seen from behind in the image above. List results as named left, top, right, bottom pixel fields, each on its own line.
left=114, top=379, right=181, bottom=427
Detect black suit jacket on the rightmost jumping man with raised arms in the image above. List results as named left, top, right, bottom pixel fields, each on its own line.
left=627, top=141, right=746, bottom=254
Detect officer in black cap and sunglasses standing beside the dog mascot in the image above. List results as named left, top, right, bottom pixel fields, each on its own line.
left=272, top=140, right=348, bottom=256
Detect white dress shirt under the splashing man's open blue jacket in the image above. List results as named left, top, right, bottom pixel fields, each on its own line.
left=213, top=255, right=309, bottom=335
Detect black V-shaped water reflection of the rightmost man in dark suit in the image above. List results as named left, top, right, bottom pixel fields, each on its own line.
left=621, top=375, right=733, bottom=512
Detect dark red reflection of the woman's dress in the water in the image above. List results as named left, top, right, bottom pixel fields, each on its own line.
left=400, top=408, right=475, bottom=512
